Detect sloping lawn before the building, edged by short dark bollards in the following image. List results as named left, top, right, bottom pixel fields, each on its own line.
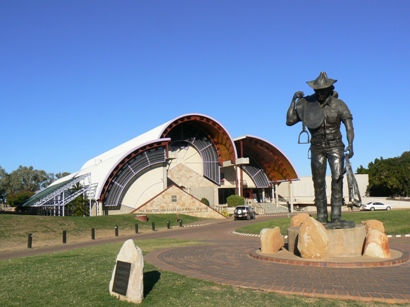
left=0, top=214, right=203, bottom=251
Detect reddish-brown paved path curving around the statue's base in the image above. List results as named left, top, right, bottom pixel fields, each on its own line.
left=0, top=216, right=410, bottom=304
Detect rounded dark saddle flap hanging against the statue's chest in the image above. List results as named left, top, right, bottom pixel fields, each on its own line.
left=296, top=99, right=325, bottom=129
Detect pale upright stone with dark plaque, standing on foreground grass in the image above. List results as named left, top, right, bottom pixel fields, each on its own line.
left=109, top=239, right=144, bottom=304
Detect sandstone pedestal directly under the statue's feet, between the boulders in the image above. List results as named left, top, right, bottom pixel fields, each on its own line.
left=288, top=224, right=366, bottom=258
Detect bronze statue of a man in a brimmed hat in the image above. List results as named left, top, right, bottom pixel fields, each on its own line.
left=286, top=72, right=354, bottom=228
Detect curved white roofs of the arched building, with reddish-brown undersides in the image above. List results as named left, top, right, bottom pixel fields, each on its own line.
left=28, top=113, right=297, bottom=212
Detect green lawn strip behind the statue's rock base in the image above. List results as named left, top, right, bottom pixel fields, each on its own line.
left=236, top=210, right=410, bottom=235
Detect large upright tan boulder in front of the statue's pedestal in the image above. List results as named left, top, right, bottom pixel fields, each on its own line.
left=297, top=217, right=330, bottom=259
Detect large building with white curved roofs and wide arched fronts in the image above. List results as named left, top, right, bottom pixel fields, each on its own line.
left=24, top=114, right=297, bottom=214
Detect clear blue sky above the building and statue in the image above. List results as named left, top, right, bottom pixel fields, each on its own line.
left=0, top=0, right=410, bottom=176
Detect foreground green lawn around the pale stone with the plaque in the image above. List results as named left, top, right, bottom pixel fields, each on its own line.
left=0, top=239, right=384, bottom=307
